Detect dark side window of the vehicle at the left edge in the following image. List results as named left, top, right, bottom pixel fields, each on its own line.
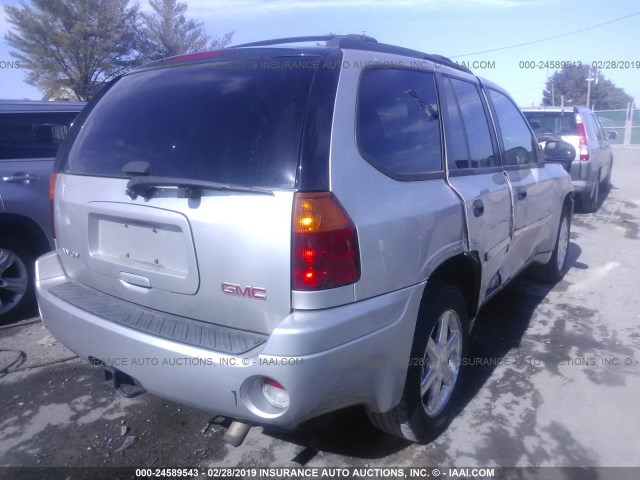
left=0, top=112, right=77, bottom=160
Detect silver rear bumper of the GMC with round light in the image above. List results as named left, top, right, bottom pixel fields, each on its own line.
left=36, top=252, right=424, bottom=427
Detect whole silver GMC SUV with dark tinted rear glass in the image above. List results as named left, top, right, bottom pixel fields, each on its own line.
left=37, top=35, right=573, bottom=442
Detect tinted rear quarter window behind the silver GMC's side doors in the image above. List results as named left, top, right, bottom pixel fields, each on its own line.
left=357, top=68, right=442, bottom=175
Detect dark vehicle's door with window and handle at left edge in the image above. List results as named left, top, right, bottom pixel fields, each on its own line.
left=0, top=112, right=77, bottom=246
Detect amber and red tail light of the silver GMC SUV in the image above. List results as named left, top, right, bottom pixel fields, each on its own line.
left=292, top=192, right=360, bottom=290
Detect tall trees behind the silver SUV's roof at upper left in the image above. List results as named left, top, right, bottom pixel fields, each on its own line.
left=4, top=0, right=234, bottom=101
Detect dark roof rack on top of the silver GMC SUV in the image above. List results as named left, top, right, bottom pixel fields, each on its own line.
left=230, top=34, right=472, bottom=73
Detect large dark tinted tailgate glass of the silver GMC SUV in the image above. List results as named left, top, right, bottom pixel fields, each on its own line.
left=66, top=57, right=315, bottom=188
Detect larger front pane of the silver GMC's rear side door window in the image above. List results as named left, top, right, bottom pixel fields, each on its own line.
left=451, top=78, right=500, bottom=168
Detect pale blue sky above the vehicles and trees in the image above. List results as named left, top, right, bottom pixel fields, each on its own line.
left=0, top=0, right=640, bottom=109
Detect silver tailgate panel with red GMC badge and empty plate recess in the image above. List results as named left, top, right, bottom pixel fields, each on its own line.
left=55, top=175, right=293, bottom=333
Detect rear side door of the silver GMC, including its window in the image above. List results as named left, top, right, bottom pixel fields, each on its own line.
left=442, top=76, right=512, bottom=301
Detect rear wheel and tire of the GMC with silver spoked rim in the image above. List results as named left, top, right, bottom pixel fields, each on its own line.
left=367, top=283, right=468, bottom=443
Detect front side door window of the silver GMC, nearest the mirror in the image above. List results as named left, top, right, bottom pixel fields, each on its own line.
left=489, top=90, right=538, bottom=166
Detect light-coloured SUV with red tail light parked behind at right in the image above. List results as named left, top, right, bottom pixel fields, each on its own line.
left=522, top=107, right=618, bottom=212
